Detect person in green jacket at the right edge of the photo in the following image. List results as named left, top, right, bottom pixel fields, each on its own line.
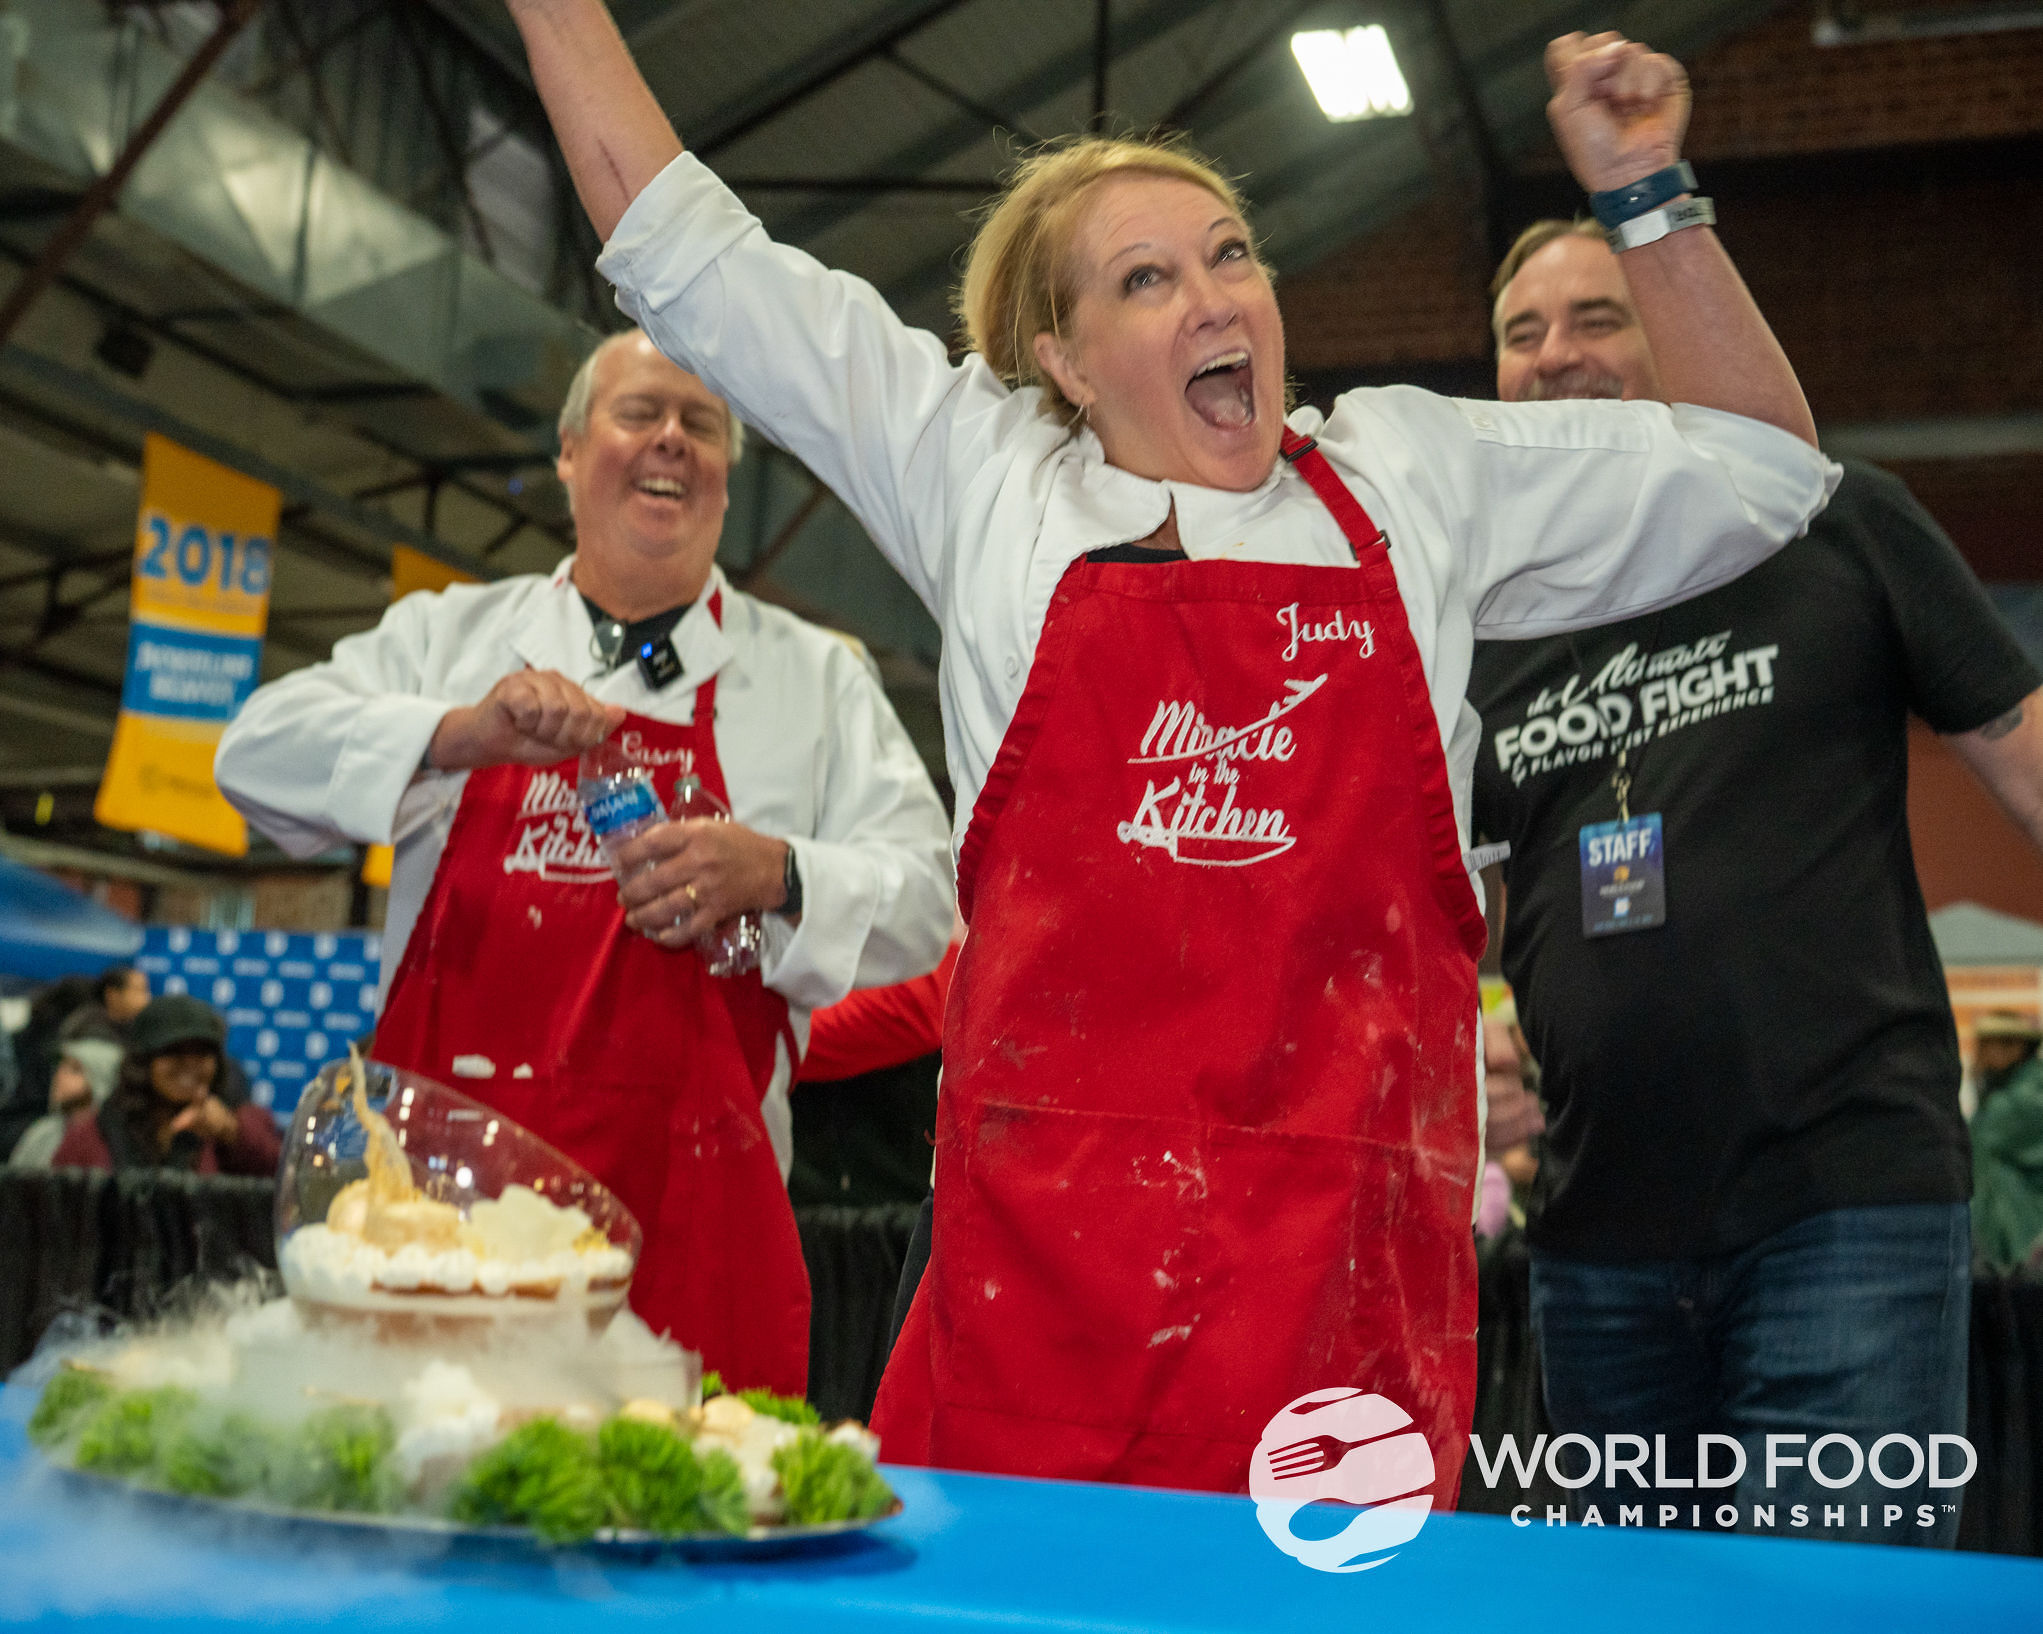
left=1971, top=1009, right=2043, bottom=1270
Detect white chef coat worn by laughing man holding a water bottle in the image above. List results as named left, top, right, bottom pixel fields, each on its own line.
left=215, top=558, right=954, bottom=1174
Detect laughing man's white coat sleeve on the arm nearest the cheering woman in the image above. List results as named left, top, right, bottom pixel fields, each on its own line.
left=760, top=647, right=956, bottom=1009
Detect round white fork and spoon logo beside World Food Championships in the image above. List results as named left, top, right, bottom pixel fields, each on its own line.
left=1248, top=1389, right=1434, bottom=1573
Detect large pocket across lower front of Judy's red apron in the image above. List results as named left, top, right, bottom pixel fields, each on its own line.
left=932, top=1101, right=1408, bottom=1442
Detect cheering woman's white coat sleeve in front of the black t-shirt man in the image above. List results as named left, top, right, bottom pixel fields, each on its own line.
left=1350, top=388, right=1841, bottom=639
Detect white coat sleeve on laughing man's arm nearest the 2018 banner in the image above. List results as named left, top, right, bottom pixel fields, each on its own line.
left=212, top=592, right=467, bottom=856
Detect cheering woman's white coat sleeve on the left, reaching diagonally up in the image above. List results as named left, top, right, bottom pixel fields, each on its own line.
left=597, top=153, right=1034, bottom=607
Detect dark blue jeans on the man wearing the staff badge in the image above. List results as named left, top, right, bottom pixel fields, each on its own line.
left=1532, top=1203, right=1971, bottom=1548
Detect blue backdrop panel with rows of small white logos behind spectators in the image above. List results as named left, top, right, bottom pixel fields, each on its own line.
left=135, top=925, right=382, bottom=1121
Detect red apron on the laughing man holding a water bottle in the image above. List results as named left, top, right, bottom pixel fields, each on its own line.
left=376, top=633, right=809, bottom=1395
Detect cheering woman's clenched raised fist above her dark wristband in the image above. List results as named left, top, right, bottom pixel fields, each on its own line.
left=1547, top=33, right=1692, bottom=192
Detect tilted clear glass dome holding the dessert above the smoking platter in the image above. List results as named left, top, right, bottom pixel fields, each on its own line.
left=276, top=1060, right=642, bottom=1326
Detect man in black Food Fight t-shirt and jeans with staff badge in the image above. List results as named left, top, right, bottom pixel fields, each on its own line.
left=1469, top=223, right=2043, bottom=1544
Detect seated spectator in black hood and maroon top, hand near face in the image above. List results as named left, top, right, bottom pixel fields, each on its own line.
left=53, top=993, right=282, bottom=1174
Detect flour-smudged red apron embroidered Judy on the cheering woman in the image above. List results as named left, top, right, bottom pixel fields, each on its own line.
left=874, top=433, right=1483, bottom=1507
